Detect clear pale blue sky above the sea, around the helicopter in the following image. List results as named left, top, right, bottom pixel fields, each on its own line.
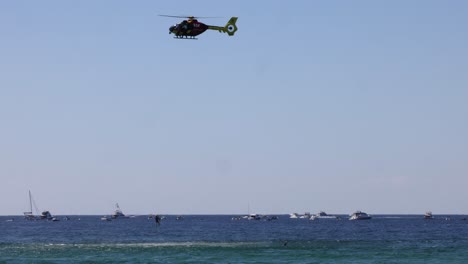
left=0, top=0, right=468, bottom=214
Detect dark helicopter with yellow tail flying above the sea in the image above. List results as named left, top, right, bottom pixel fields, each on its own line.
left=160, top=15, right=237, bottom=39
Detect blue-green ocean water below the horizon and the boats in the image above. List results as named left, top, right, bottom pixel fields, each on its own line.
left=0, top=215, right=468, bottom=263
